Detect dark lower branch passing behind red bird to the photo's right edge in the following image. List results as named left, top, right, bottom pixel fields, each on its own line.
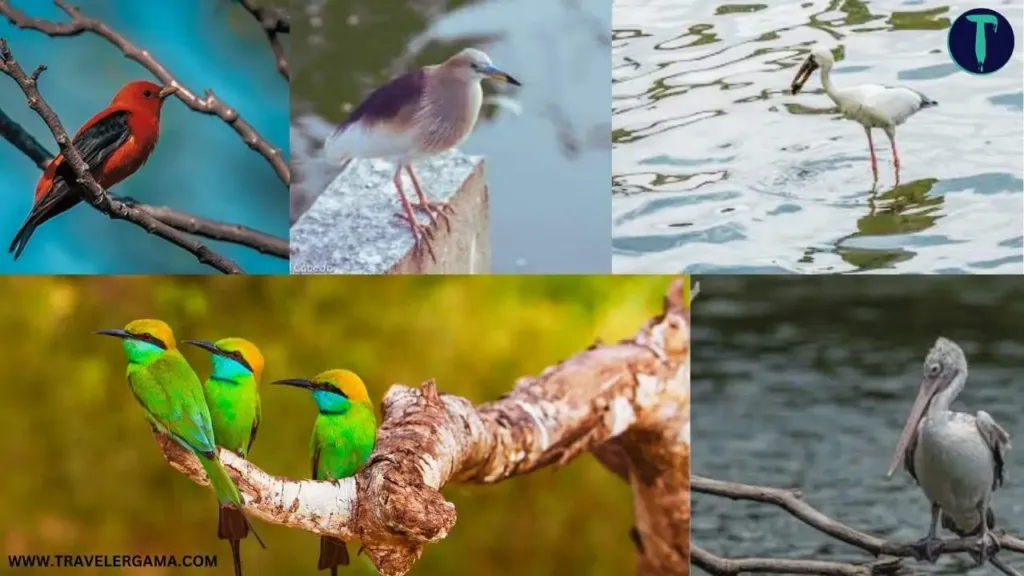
left=0, top=101, right=289, bottom=258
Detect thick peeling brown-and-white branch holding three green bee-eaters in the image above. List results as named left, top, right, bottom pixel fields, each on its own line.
left=149, top=282, right=689, bottom=576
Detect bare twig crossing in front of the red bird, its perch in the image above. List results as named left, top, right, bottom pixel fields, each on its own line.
left=0, top=38, right=242, bottom=274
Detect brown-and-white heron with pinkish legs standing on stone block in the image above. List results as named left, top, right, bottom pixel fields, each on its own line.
left=324, top=48, right=520, bottom=255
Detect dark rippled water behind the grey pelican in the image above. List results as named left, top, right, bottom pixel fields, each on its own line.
left=692, top=277, right=1024, bottom=574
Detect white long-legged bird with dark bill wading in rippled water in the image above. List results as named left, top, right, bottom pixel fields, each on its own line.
left=791, top=46, right=939, bottom=183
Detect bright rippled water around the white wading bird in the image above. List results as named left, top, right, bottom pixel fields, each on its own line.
left=612, top=0, right=1024, bottom=274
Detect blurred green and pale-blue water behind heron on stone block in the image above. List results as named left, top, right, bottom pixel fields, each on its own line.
left=292, top=0, right=611, bottom=273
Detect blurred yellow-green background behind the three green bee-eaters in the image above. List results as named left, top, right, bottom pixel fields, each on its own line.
left=0, top=276, right=669, bottom=576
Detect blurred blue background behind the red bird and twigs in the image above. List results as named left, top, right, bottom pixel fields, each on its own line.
left=0, top=0, right=290, bottom=274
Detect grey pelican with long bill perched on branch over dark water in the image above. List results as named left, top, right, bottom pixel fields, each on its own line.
left=886, top=337, right=1010, bottom=566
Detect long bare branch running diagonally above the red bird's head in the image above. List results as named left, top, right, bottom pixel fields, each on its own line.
left=0, top=0, right=292, bottom=187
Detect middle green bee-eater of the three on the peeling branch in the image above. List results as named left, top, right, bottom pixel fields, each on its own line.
left=182, top=338, right=263, bottom=576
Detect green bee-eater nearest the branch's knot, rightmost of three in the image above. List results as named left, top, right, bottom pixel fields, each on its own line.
left=274, top=370, right=377, bottom=576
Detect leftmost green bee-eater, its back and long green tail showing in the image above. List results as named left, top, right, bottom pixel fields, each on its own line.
left=96, top=320, right=263, bottom=557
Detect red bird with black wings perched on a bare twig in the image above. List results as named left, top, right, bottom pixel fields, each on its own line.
left=7, top=80, right=178, bottom=260
